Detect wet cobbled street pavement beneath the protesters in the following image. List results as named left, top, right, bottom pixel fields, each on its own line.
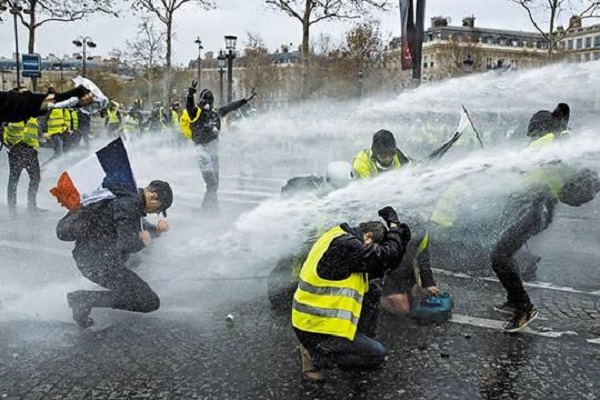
left=0, top=135, right=600, bottom=400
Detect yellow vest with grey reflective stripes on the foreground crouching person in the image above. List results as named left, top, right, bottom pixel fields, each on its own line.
left=292, top=226, right=369, bottom=340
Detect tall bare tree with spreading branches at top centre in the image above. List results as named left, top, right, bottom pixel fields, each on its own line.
left=265, top=0, right=391, bottom=98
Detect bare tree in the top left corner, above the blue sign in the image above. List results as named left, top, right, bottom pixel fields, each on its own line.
left=6, top=0, right=118, bottom=89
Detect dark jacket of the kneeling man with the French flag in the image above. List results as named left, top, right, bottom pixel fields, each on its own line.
left=56, top=188, right=145, bottom=266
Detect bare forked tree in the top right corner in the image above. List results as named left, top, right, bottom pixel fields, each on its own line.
left=508, top=0, right=600, bottom=60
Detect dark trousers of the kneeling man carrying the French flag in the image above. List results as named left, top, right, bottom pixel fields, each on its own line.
left=77, top=262, right=160, bottom=313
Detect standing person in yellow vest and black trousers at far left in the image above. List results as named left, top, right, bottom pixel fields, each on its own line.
left=4, top=118, right=43, bottom=215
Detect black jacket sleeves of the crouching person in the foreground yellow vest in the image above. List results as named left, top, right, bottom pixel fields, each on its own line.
left=317, top=224, right=408, bottom=281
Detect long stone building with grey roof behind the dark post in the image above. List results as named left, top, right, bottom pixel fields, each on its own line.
left=385, top=17, right=548, bottom=81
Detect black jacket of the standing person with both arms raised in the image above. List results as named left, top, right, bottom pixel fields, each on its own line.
left=186, top=94, right=248, bottom=144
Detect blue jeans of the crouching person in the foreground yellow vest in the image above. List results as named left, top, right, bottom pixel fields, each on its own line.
left=311, top=332, right=387, bottom=369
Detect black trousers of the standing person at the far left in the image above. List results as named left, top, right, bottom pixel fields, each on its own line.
left=7, top=142, right=40, bottom=211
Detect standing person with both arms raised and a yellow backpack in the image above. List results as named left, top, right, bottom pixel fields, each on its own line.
left=180, top=81, right=256, bottom=213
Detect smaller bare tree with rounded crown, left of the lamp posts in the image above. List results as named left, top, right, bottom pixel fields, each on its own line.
left=111, top=17, right=166, bottom=104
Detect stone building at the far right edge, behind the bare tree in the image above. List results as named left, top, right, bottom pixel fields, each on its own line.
left=559, top=17, right=600, bottom=62
